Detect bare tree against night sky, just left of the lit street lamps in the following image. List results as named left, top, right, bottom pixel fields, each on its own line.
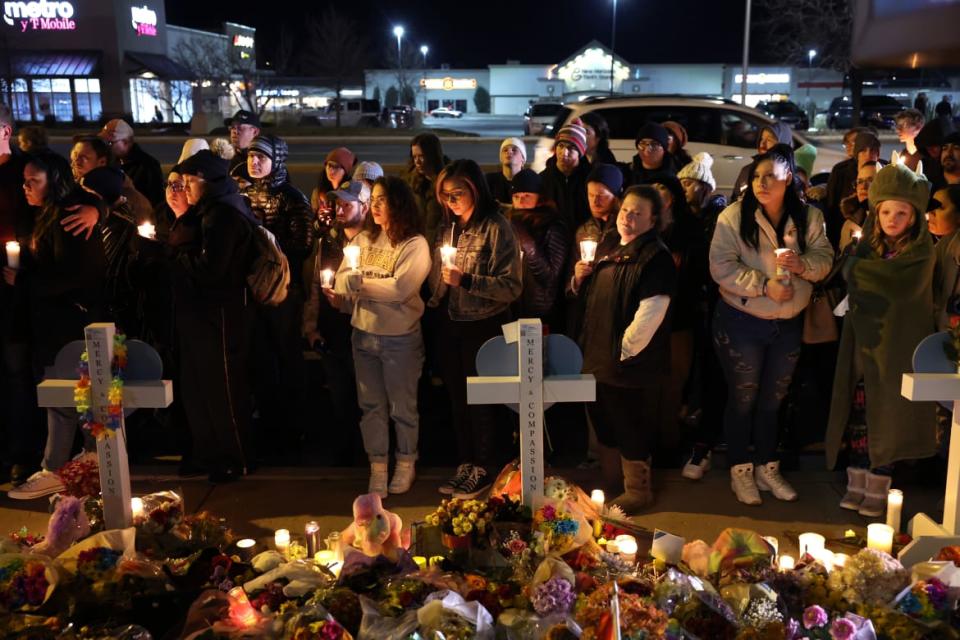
left=304, top=4, right=368, bottom=127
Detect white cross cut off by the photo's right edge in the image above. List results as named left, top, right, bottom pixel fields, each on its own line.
left=898, top=373, right=960, bottom=567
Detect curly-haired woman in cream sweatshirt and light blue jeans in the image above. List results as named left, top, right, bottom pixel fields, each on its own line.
left=336, top=177, right=430, bottom=498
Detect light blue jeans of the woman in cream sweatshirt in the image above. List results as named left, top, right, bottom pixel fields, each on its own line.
left=352, top=327, right=423, bottom=462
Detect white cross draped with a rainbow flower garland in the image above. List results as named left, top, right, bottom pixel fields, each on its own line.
left=37, top=322, right=173, bottom=529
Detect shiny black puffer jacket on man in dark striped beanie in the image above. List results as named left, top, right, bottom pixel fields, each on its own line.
left=242, top=138, right=315, bottom=287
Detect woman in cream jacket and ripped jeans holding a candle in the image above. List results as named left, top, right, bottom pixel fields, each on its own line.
left=710, top=144, right=833, bottom=505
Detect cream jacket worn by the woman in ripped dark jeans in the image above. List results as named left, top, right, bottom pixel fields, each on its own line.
left=710, top=202, right=833, bottom=320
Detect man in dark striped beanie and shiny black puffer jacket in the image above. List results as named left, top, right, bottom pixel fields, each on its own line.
left=242, top=135, right=314, bottom=442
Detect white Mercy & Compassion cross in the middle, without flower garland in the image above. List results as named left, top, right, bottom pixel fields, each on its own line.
left=467, top=318, right=596, bottom=507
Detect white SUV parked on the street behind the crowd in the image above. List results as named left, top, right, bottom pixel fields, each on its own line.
left=532, top=96, right=846, bottom=195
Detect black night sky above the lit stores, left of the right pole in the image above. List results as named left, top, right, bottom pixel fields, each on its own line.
left=166, top=0, right=753, bottom=68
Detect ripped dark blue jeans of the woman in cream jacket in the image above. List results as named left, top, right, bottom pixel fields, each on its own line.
left=713, top=300, right=803, bottom=467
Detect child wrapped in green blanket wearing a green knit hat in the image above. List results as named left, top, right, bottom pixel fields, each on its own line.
left=826, top=163, right=937, bottom=517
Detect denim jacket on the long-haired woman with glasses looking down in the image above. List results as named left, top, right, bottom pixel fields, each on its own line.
left=427, top=211, right=523, bottom=320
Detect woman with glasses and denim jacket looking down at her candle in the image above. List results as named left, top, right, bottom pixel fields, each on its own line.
left=427, top=160, right=523, bottom=497
